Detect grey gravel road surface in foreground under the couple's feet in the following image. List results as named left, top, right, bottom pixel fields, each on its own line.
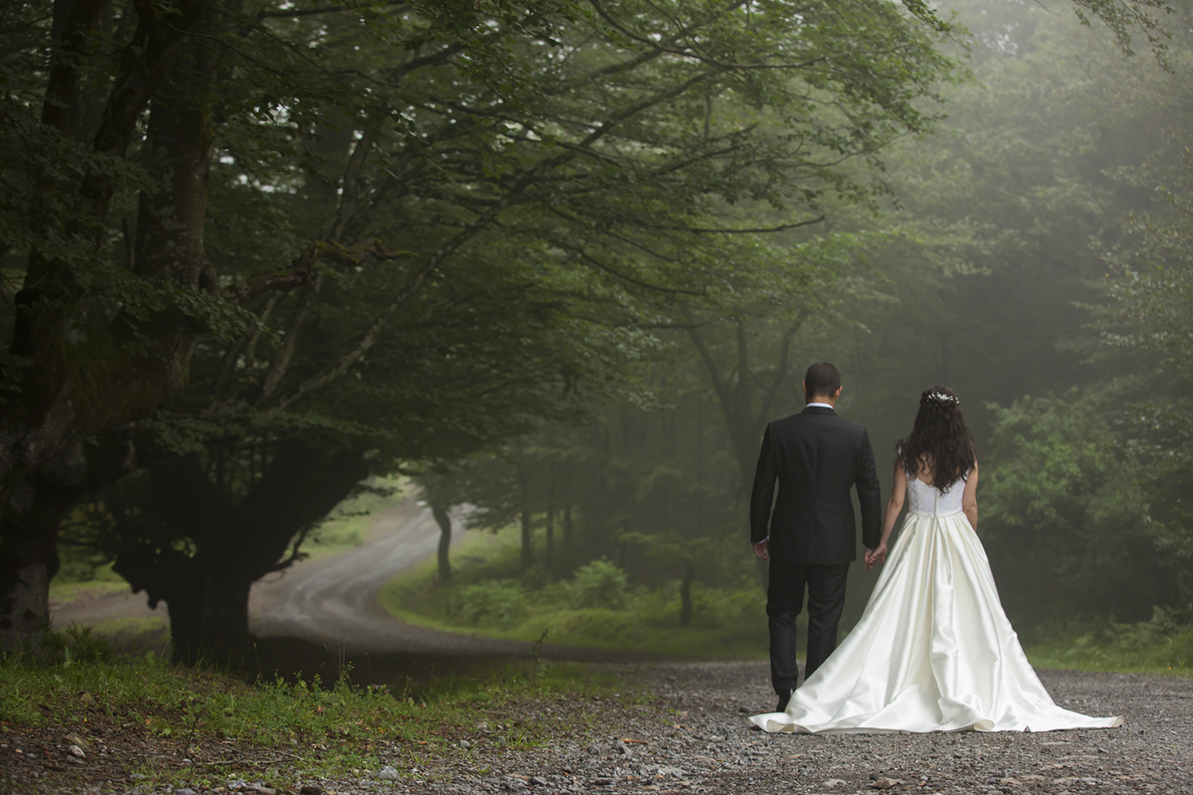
left=295, top=663, right=1193, bottom=795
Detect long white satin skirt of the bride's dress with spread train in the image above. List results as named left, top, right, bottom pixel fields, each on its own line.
left=750, top=512, right=1123, bottom=734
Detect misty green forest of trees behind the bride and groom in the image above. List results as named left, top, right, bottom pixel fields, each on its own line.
left=0, top=0, right=1193, bottom=664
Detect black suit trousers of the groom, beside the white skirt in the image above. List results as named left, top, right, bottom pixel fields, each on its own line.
left=766, top=559, right=849, bottom=696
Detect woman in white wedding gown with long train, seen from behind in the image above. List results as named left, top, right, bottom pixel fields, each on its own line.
left=750, top=387, right=1123, bottom=733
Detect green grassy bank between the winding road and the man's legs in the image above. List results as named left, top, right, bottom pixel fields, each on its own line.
left=378, top=528, right=767, bottom=659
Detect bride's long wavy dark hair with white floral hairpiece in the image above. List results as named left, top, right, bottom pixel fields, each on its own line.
left=895, top=387, right=977, bottom=489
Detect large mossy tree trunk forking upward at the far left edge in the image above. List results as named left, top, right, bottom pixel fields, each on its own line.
left=0, top=0, right=309, bottom=649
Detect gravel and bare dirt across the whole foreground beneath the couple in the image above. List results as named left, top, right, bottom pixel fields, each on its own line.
left=7, top=663, right=1193, bottom=795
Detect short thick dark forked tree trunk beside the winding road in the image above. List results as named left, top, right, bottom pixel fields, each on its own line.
left=109, top=442, right=369, bottom=667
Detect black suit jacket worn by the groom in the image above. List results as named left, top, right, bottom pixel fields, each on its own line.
left=749, top=406, right=882, bottom=565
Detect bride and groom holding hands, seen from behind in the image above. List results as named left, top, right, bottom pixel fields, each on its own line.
left=750, top=362, right=1123, bottom=733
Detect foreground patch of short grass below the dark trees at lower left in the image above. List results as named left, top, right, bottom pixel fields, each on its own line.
left=0, top=630, right=628, bottom=791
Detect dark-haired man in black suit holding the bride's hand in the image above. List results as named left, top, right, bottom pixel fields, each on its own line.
left=749, top=362, right=882, bottom=713
